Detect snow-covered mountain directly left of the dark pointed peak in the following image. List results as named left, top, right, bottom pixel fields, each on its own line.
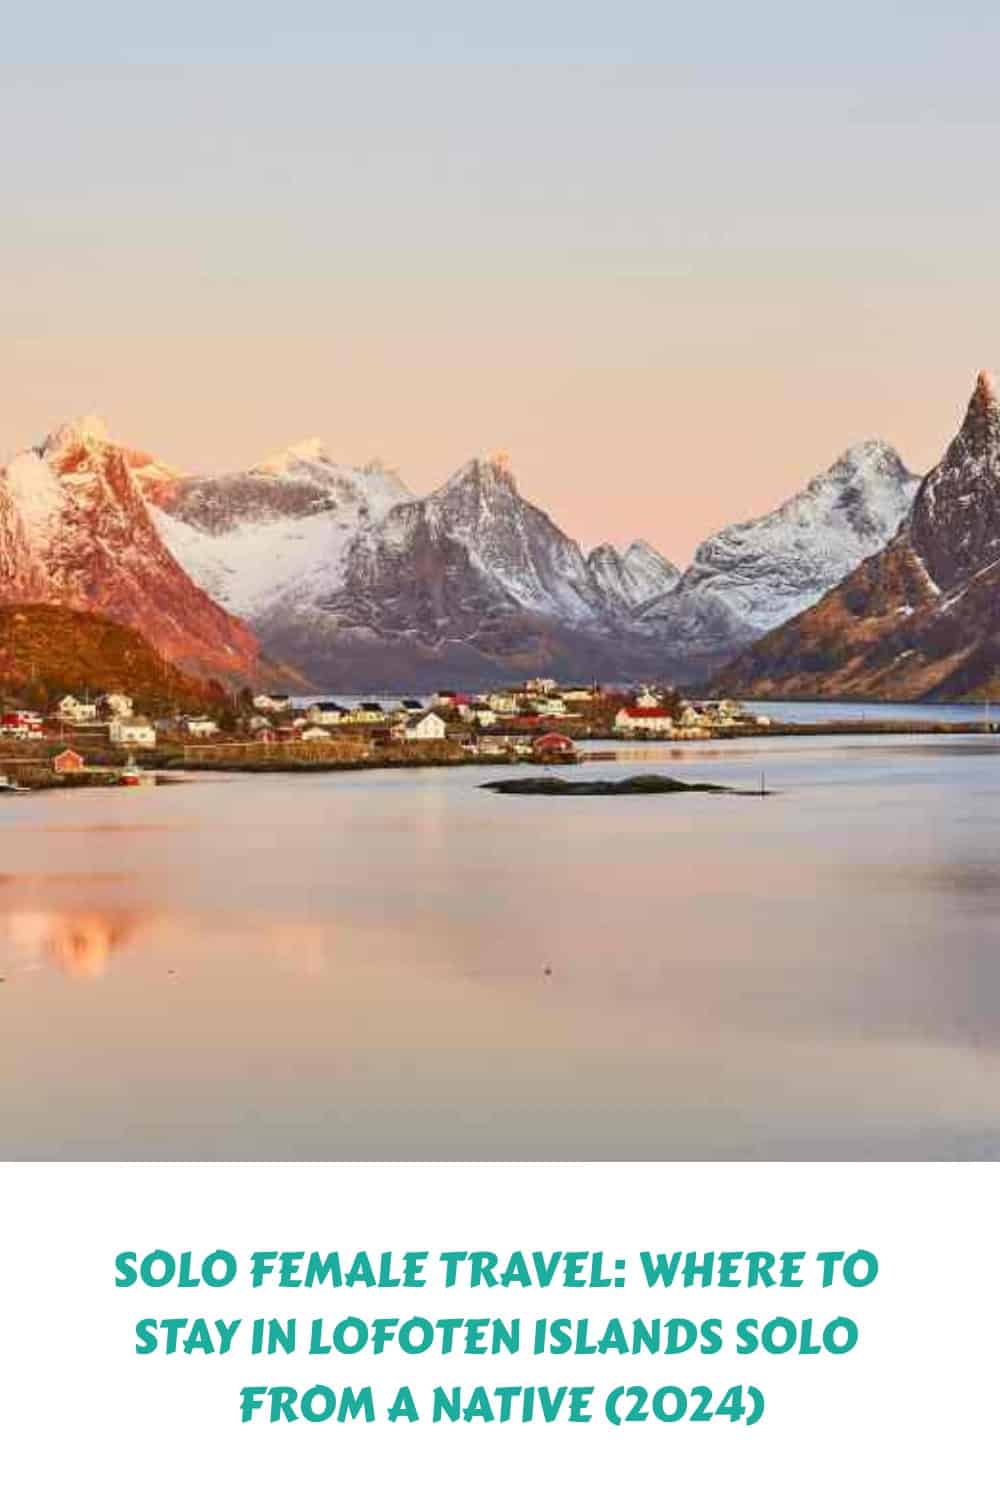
left=637, top=441, right=919, bottom=665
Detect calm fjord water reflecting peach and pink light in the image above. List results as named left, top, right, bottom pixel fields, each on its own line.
left=0, top=735, right=1000, bottom=1160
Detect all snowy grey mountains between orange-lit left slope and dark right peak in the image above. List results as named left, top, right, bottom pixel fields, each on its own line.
left=150, top=441, right=918, bottom=692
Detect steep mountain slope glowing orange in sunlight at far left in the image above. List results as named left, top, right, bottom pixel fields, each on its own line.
left=0, top=419, right=268, bottom=680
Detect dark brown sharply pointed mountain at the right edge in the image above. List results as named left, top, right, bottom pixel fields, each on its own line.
left=718, top=372, right=1000, bottom=701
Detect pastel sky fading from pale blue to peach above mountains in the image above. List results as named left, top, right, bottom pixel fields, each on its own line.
left=0, top=0, right=1000, bottom=561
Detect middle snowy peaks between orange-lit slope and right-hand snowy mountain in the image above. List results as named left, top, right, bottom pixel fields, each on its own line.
left=157, top=444, right=689, bottom=690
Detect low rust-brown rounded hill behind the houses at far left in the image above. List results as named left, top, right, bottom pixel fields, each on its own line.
left=0, top=605, right=217, bottom=713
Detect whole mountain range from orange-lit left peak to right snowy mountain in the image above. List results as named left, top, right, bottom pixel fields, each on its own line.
left=0, top=405, right=941, bottom=692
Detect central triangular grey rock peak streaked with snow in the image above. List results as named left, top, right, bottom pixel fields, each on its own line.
left=245, top=455, right=669, bottom=689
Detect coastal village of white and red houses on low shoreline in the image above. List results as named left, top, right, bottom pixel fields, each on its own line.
left=0, top=678, right=771, bottom=789
